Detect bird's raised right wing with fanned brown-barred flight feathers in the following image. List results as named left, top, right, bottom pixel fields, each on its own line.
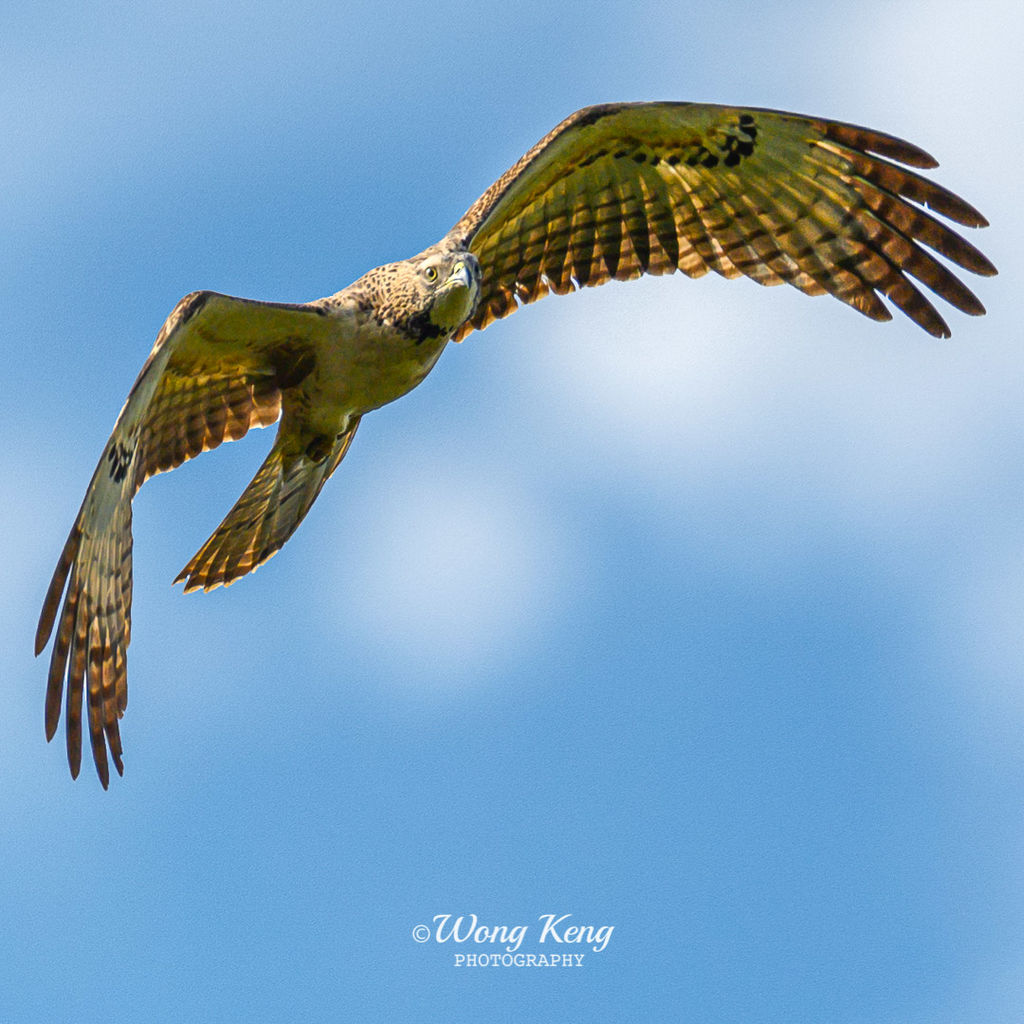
left=447, top=102, right=995, bottom=340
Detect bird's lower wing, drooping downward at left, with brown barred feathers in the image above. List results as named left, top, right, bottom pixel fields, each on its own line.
left=36, top=292, right=331, bottom=788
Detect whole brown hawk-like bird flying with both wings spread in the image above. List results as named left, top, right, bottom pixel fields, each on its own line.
left=36, top=102, right=995, bottom=788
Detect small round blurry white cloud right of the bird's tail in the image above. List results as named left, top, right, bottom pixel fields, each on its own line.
left=327, top=460, right=566, bottom=691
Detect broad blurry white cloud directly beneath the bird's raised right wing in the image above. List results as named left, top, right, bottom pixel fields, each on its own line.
left=512, top=279, right=1007, bottom=519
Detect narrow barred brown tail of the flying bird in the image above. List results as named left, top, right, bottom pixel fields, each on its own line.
left=174, top=417, right=359, bottom=593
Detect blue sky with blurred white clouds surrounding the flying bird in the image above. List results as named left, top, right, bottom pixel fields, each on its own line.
left=0, top=2, right=1024, bottom=1024
